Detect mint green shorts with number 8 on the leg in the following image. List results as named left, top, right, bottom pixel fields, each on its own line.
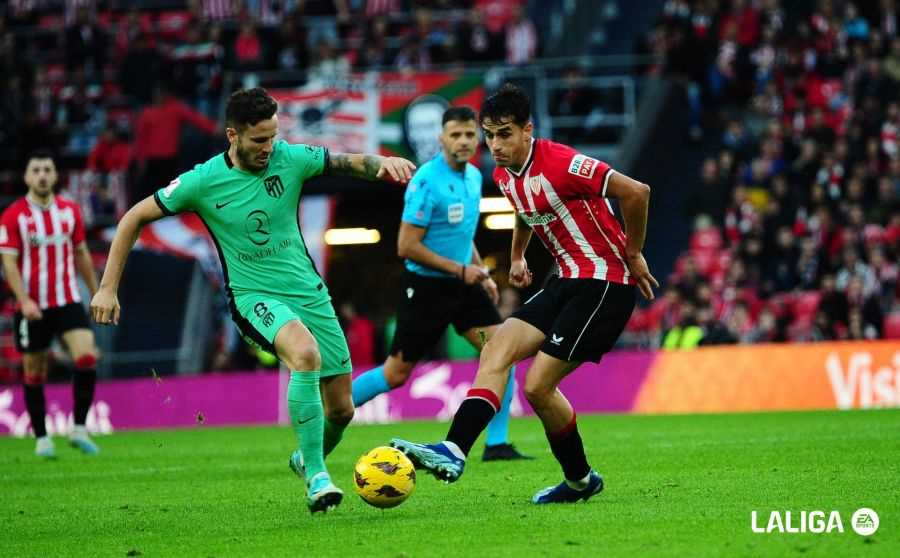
left=232, top=293, right=353, bottom=377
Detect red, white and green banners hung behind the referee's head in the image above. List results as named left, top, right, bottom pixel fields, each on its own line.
left=269, top=73, right=484, bottom=164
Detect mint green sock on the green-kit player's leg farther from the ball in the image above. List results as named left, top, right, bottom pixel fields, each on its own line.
left=287, top=371, right=326, bottom=479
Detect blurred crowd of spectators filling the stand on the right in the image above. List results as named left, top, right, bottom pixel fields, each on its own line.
left=631, top=0, right=900, bottom=348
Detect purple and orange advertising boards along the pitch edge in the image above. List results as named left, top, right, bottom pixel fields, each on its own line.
left=0, top=341, right=900, bottom=436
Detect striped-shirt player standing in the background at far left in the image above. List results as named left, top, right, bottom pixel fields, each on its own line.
left=0, top=152, right=100, bottom=458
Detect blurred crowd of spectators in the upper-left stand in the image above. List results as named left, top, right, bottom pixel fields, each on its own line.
left=0, top=0, right=538, bottom=380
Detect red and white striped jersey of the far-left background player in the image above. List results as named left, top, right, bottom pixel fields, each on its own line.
left=0, top=196, right=85, bottom=309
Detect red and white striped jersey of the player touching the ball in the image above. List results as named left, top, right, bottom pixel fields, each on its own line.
left=494, top=139, right=635, bottom=285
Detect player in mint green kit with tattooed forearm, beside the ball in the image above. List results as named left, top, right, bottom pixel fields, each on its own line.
left=91, top=88, right=415, bottom=513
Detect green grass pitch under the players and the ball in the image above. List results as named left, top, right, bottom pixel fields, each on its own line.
left=0, top=410, right=900, bottom=558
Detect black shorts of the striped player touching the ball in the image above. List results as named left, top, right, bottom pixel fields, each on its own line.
left=511, top=277, right=637, bottom=362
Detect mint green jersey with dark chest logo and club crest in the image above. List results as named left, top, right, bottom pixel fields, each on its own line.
left=154, top=140, right=329, bottom=300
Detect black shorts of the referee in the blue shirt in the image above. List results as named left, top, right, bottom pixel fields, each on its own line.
left=391, top=270, right=501, bottom=362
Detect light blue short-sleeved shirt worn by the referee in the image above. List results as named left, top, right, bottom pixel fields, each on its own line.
left=402, top=151, right=481, bottom=277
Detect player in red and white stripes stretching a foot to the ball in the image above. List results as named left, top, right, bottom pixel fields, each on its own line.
left=391, top=84, right=659, bottom=504
